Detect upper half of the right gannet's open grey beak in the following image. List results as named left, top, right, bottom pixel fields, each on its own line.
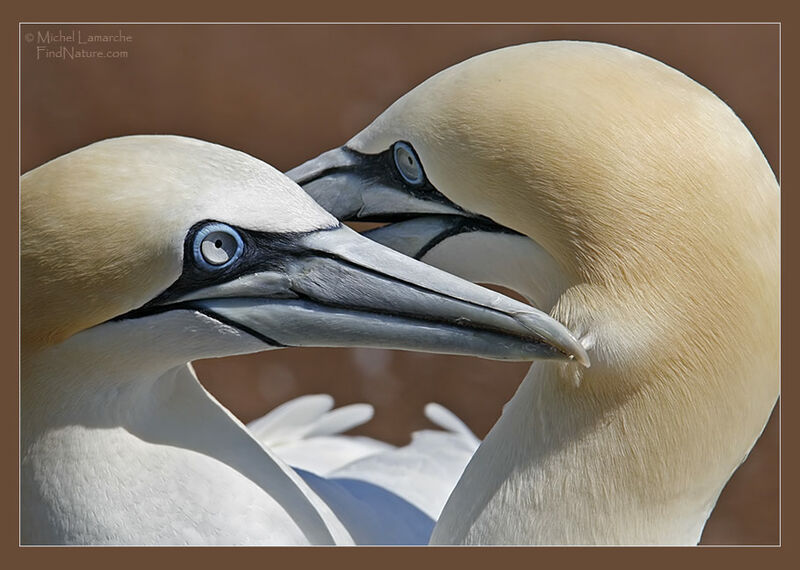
left=286, top=146, right=468, bottom=222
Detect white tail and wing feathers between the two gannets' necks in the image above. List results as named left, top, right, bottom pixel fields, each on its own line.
left=248, top=394, right=480, bottom=544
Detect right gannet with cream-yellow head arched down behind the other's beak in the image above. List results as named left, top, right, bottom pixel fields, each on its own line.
left=288, top=41, right=779, bottom=544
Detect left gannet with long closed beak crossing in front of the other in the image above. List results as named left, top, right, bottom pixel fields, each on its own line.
left=20, top=132, right=586, bottom=544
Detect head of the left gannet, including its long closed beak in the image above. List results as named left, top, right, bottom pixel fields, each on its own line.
left=21, top=136, right=585, bottom=378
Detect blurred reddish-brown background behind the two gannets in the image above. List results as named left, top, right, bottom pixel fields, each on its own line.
left=21, top=24, right=779, bottom=544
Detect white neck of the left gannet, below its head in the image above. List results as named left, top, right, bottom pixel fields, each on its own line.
left=21, top=322, right=352, bottom=544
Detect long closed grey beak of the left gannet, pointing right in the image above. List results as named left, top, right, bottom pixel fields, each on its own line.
left=121, top=222, right=588, bottom=365
